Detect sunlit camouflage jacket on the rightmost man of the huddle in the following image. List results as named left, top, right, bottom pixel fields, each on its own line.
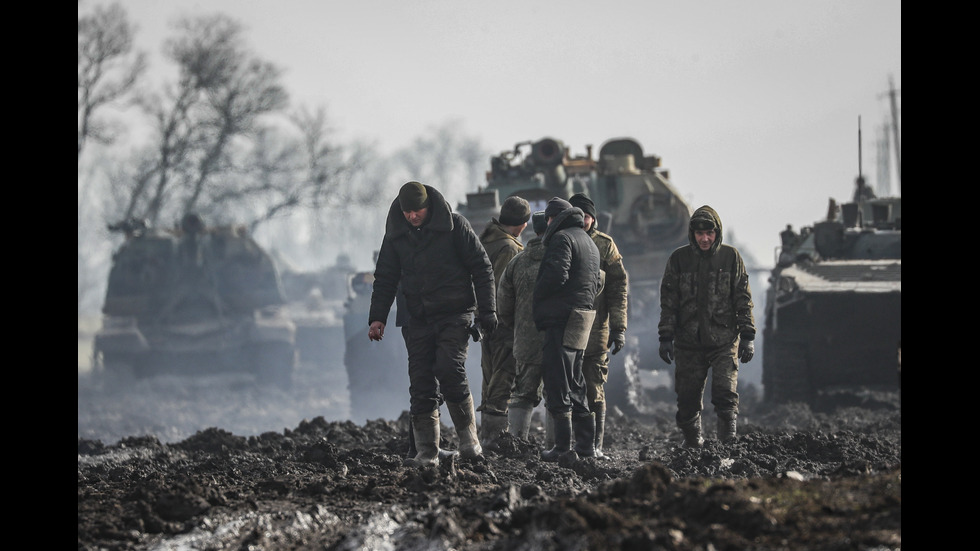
left=585, top=224, right=629, bottom=354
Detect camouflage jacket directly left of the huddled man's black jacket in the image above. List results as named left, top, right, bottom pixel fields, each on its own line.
left=497, top=237, right=544, bottom=363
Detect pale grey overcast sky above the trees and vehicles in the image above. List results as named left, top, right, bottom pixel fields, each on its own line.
left=101, top=0, right=902, bottom=265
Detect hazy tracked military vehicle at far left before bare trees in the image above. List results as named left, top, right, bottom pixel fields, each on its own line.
left=93, top=215, right=296, bottom=388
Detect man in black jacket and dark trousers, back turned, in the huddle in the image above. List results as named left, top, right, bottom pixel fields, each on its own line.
left=532, top=197, right=601, bottom=461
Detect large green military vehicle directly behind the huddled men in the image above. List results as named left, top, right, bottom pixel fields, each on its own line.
left=456, top=137, right=693, bottom=414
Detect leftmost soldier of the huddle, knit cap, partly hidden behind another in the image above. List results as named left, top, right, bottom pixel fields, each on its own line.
left=477, top=195, right=531, bottom=448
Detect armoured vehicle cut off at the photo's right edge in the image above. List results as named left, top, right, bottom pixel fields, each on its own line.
left=762, top=176, right=902, bottom=409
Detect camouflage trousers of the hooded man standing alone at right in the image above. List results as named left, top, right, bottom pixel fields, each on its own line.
left=674, top=343, right=738, bottom=425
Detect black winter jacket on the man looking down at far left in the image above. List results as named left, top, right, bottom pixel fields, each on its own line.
left=368, top=185, right=496, bottom=325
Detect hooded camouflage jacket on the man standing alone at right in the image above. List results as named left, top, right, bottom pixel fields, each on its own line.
left=659, top=206, right=755, bottom=349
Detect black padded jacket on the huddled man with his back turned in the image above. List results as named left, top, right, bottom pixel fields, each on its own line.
left=533, top=207, right=601, bottom=331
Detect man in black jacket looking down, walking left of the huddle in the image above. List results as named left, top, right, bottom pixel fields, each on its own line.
left=368, top=182, right=497, bottom=466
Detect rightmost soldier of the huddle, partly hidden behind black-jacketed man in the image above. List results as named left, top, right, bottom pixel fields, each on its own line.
left=568, top=193, right=629, bottom=459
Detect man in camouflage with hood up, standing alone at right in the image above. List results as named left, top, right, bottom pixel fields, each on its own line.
left=659, top=205, right=755, bottom=447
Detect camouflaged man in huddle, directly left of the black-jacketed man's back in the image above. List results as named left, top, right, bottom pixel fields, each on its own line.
left=497, top=210, right=554, bottom=445
